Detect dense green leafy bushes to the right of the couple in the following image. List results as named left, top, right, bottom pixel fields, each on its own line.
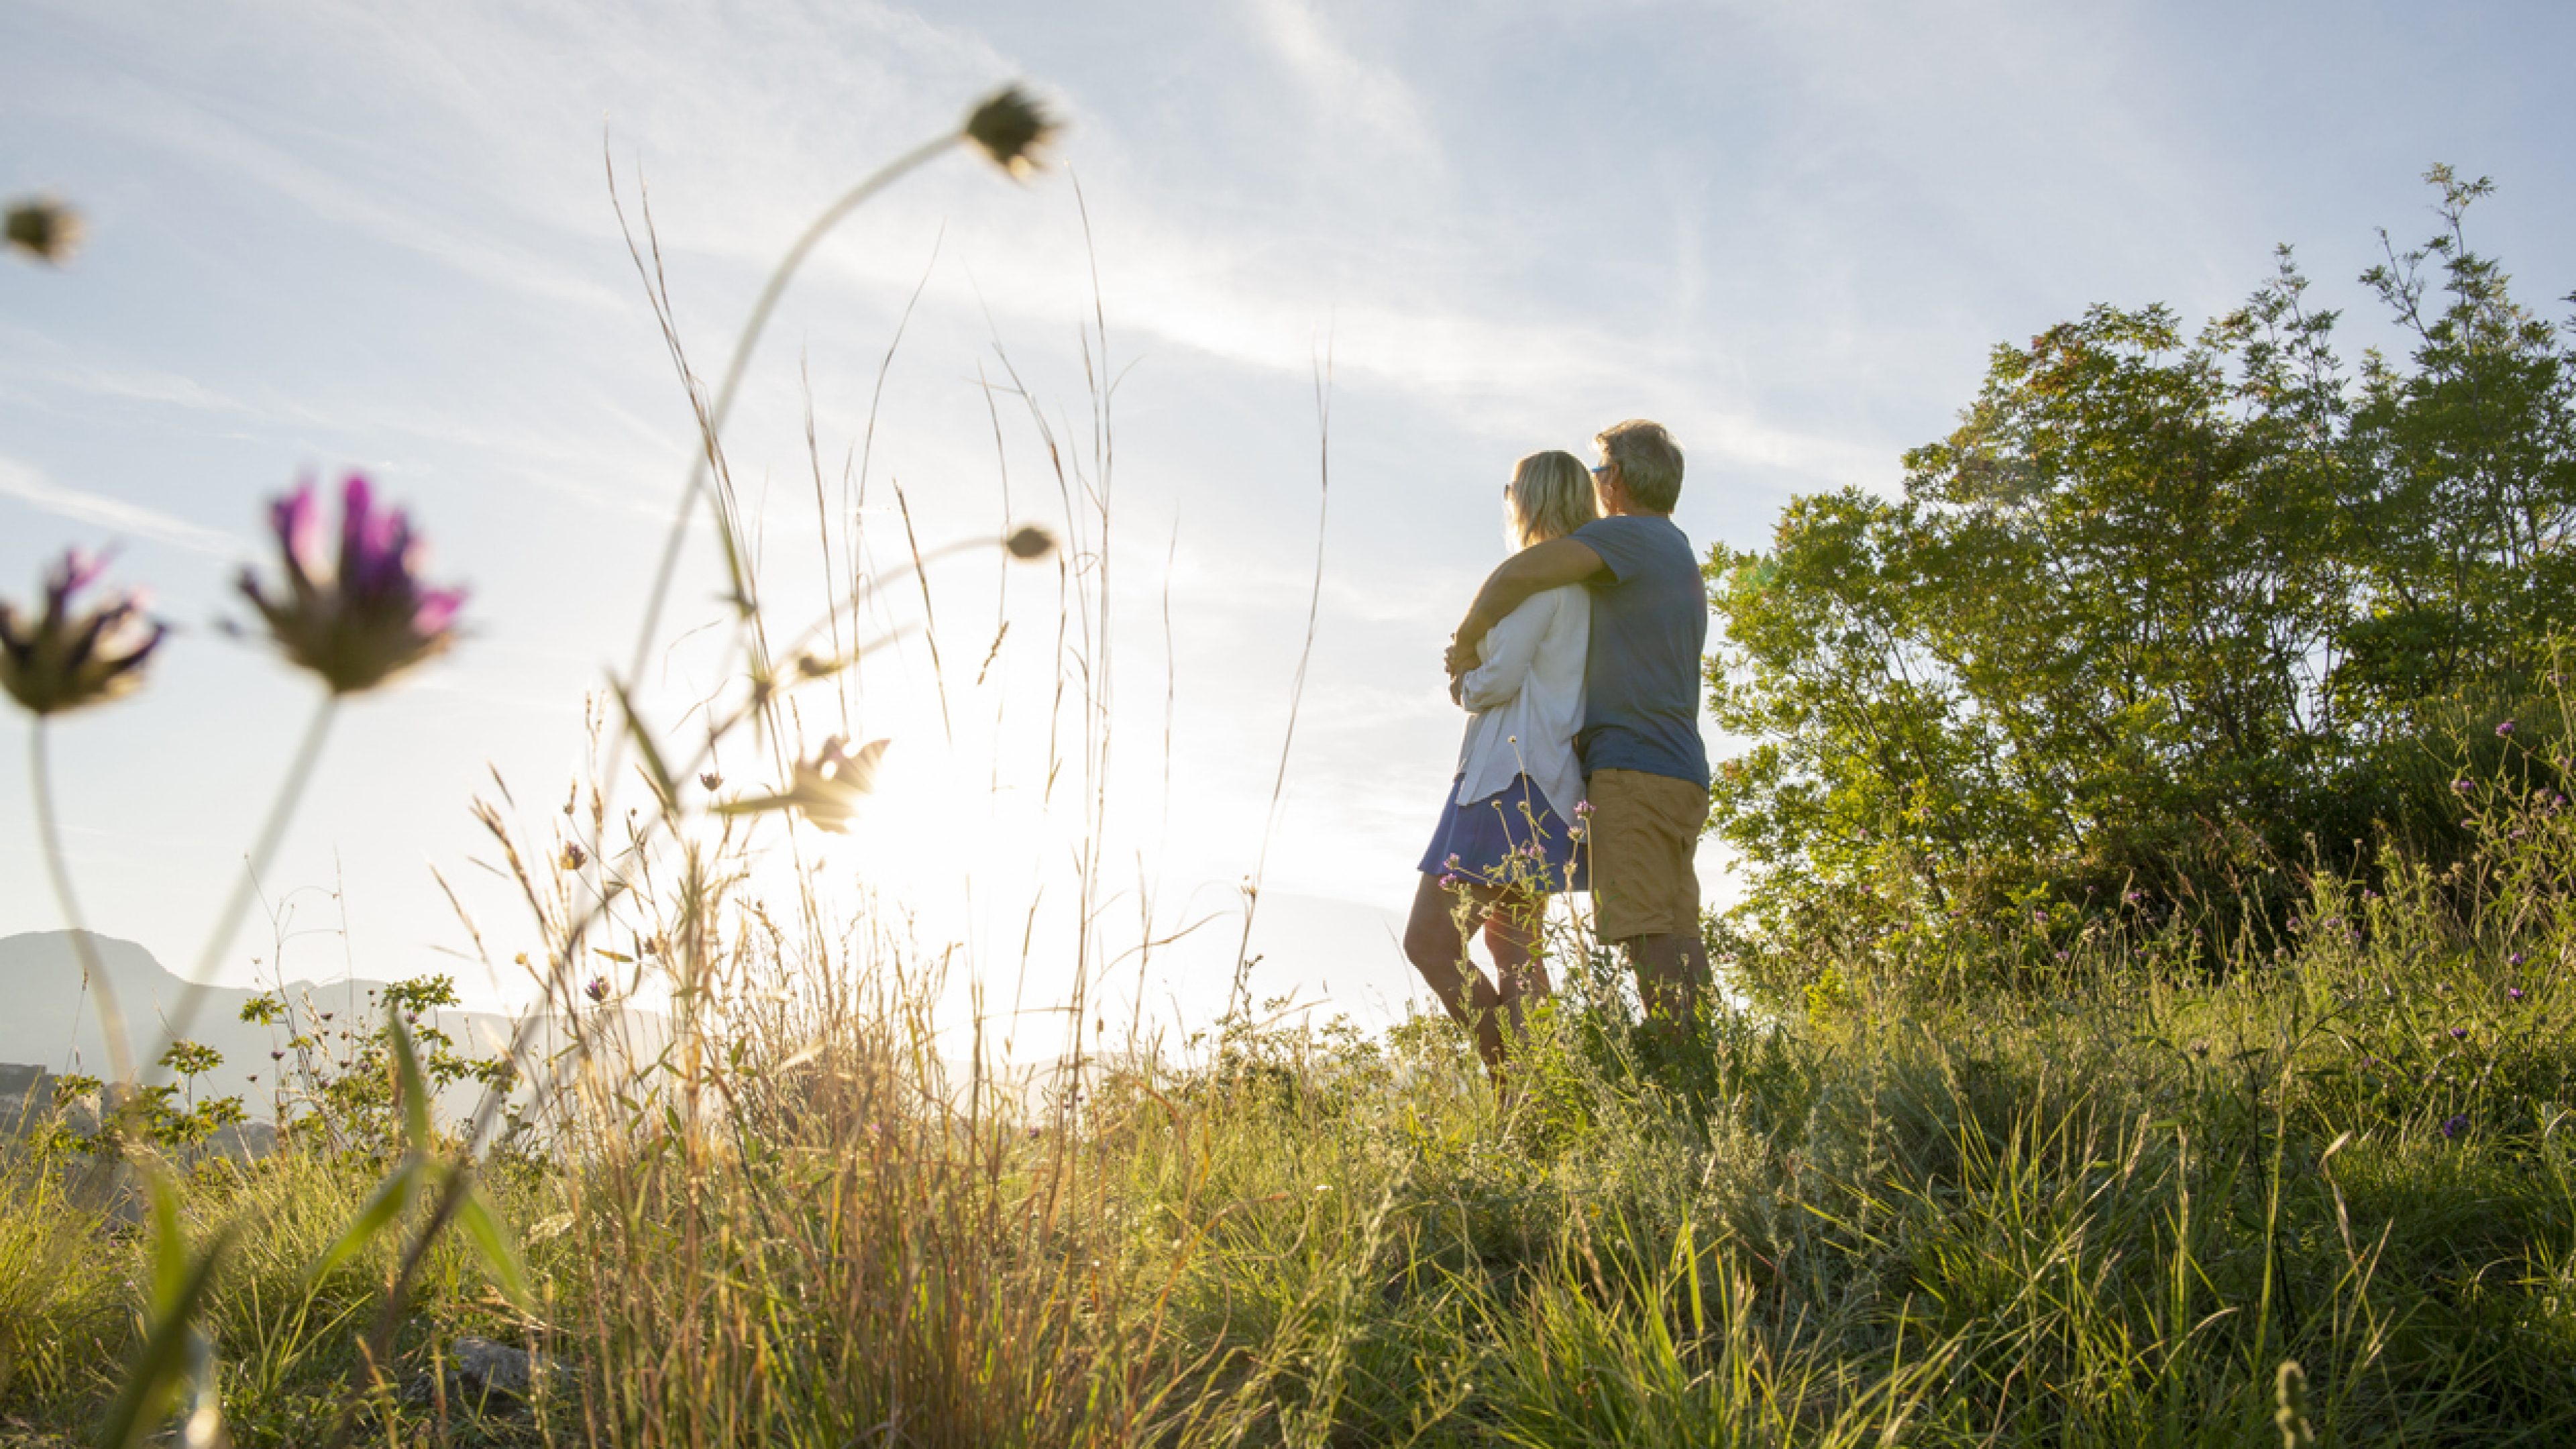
left=1708, top=168, right=2576, bottom=944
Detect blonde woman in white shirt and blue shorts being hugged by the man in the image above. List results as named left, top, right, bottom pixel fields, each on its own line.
left=1404, top=451, right=1600, bottom=1073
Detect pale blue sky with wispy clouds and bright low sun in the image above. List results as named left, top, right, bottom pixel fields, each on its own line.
left=0, top=0, right=2576, bottom=1026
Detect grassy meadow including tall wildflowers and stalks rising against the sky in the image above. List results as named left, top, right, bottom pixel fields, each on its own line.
left=0, top=98, right=2576, bottom=1449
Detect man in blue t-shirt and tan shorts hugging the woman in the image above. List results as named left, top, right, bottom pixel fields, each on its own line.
left=1448, top=420, right=1708, bottom=1039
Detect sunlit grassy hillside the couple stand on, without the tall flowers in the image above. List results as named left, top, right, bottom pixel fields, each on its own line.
left=0, top=778, right=2576, bottom=1446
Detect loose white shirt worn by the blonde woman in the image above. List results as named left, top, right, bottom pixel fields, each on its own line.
left=1456, top=583, right=1592, bottom=825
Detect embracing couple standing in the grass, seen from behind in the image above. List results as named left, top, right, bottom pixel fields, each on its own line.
left=1404, top=420, right=1708, bottom=1070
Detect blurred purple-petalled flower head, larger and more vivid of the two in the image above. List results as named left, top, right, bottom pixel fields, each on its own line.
left=239, top=474, right=466, bottom=694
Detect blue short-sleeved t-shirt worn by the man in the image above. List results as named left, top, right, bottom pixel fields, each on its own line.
left=1574, top=513, right=1708, bottom=789
